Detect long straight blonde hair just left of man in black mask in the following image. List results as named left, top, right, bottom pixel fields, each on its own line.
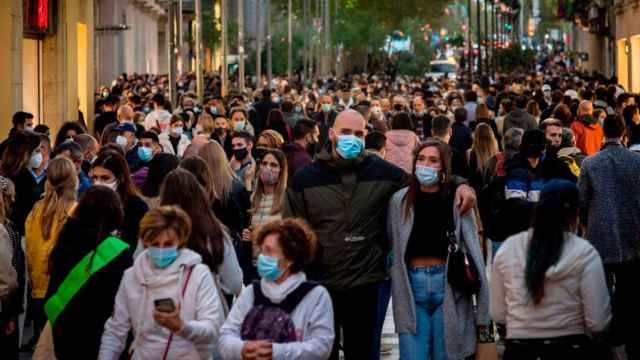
left=198, top=141, right=236, bottom=202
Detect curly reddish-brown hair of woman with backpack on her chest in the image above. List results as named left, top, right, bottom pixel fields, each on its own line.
left=253, top=218, right=317, bottom=273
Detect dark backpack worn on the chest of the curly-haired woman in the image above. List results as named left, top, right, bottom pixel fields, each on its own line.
left=240, top=280, right=319, bottom=344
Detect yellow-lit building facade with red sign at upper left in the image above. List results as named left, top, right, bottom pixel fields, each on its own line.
left=0, top=0, right=94, bottom=138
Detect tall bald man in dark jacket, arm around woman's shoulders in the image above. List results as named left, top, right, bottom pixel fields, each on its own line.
left=283, top=110, right=475, bottom=360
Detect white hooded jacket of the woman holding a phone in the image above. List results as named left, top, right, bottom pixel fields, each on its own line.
left=98, top=249, right=223, bottom=360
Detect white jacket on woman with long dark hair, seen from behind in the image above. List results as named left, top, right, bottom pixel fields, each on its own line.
left=491, top=232, right=611, bottom=339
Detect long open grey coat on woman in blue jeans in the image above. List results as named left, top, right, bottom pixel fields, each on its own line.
left=387, top=188, right=489, bottom=360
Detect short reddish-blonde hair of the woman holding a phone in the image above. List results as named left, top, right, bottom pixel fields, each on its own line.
left=140, top=206, right=191, bottom=248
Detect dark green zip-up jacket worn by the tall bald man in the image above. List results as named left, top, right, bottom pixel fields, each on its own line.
left=283, top=144, right=406, bottom=290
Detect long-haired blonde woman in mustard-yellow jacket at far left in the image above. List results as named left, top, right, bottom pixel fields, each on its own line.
left=25, top=157, right=78, bottom=339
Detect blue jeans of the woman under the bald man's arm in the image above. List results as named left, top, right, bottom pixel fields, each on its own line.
left=399, top=265, right=447, bottom=360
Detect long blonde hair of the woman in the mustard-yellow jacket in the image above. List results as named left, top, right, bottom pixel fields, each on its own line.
left=34, top=157, right=78, bottom=241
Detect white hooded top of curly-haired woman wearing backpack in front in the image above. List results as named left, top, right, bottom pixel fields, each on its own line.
left=218, top=273, right=335, bottom=360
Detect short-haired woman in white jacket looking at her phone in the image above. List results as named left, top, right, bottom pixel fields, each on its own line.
left=98, top=206, right=223, bottom=360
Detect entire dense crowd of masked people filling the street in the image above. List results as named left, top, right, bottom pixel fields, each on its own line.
left=0, top=51, right=640, bottom=360
